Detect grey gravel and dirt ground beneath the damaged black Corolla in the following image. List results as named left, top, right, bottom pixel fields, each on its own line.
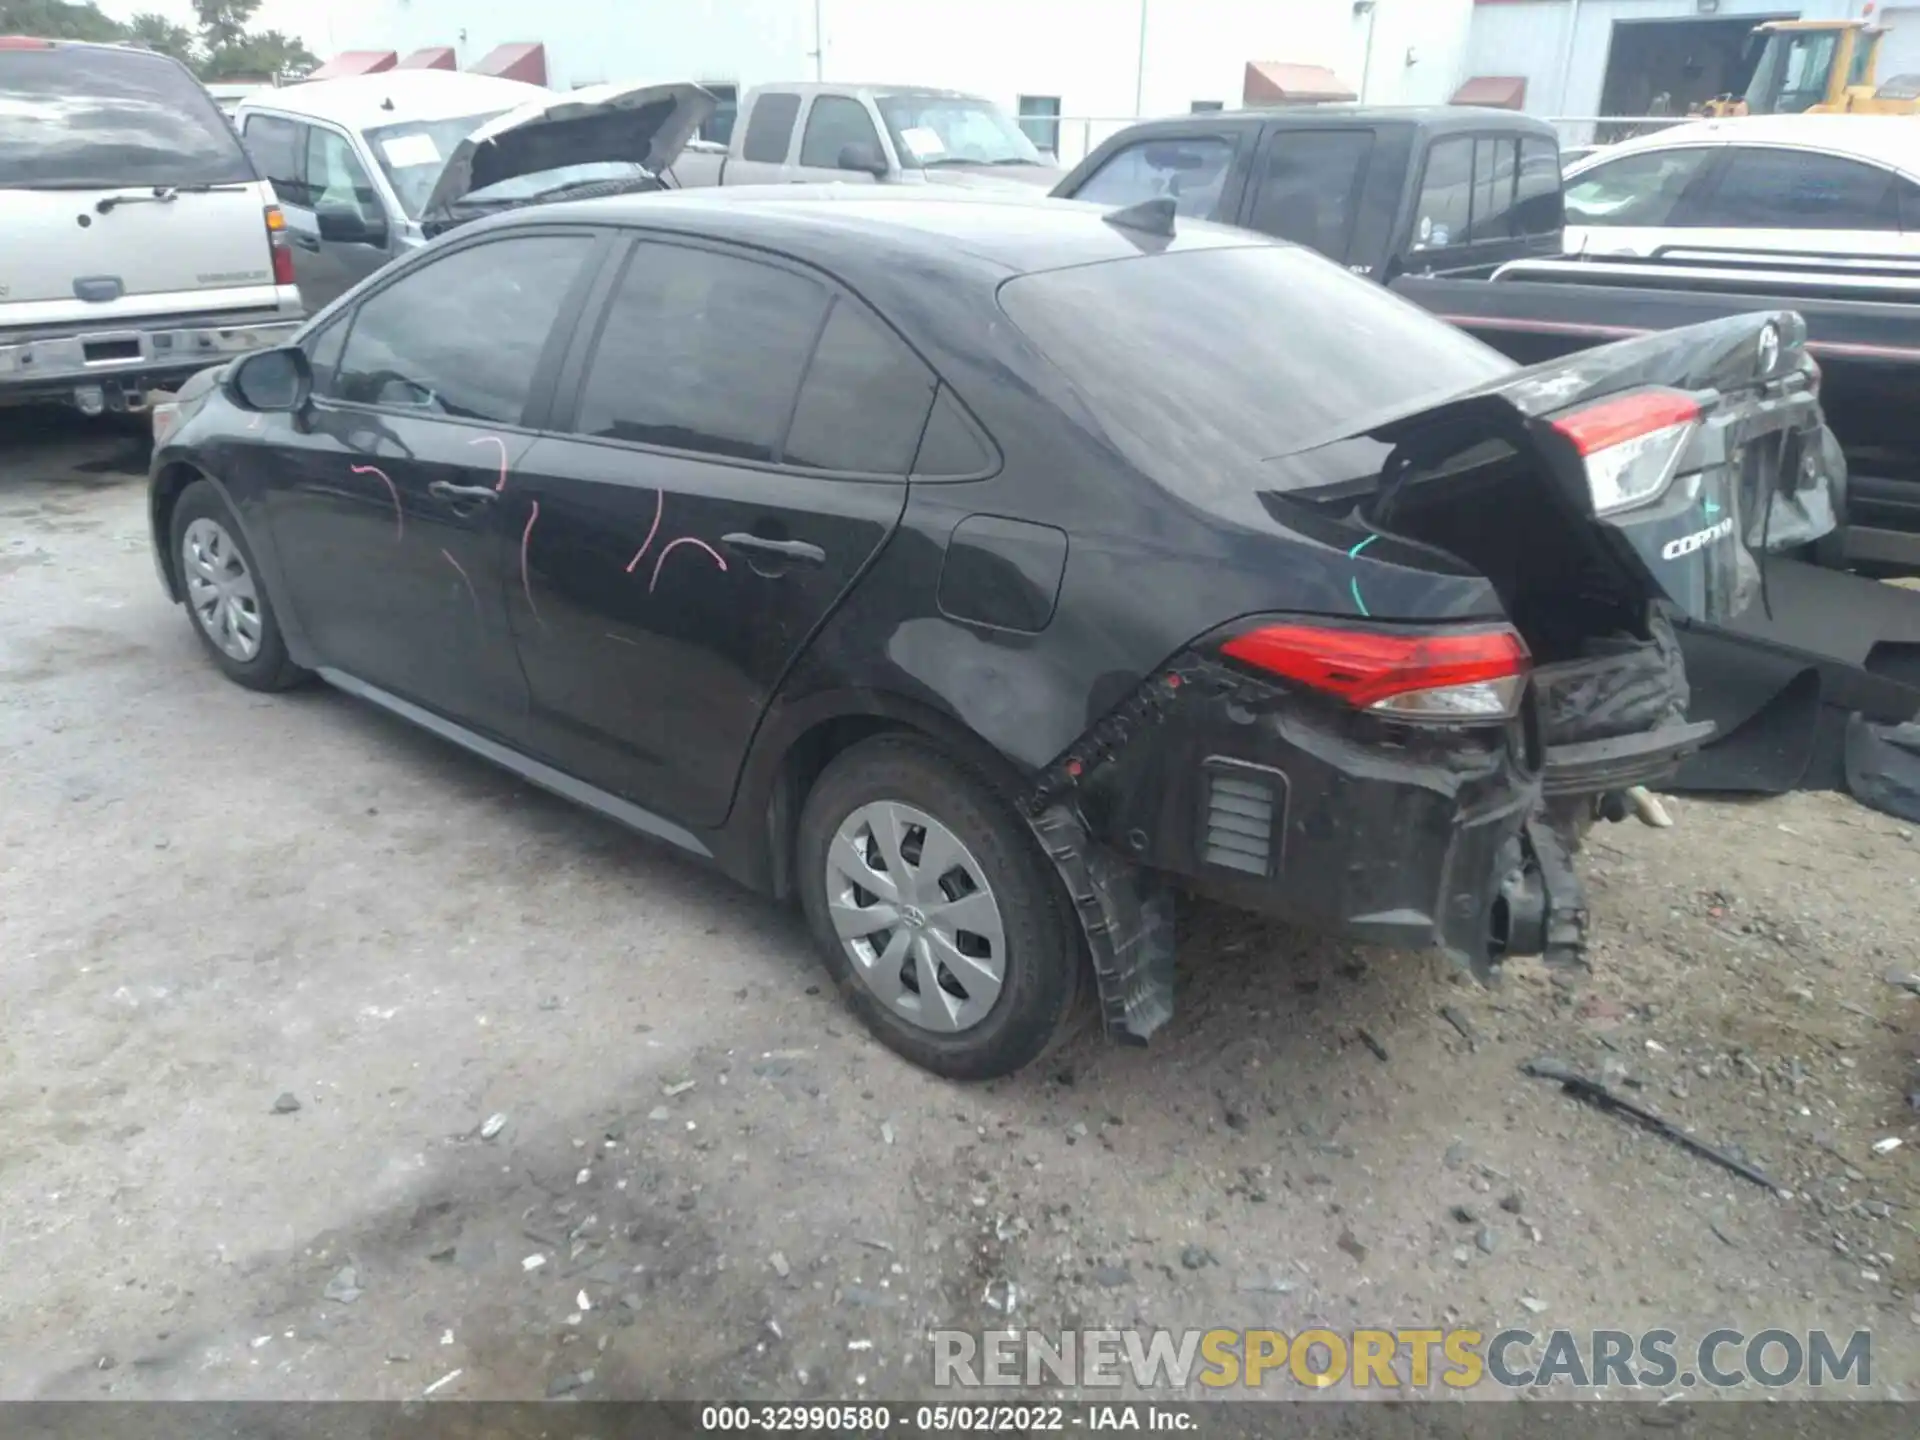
left=0, top=417, right=1920, bottom=1400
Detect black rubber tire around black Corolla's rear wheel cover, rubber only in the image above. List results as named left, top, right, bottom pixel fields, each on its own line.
left=795, top=735, right=1087, bottom=1081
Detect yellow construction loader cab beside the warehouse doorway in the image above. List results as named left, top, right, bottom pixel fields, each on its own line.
left=1692, top=19, right=1920, bottom=117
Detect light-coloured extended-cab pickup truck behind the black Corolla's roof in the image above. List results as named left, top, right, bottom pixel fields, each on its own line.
left=672, top=83, right=1064, bottom=190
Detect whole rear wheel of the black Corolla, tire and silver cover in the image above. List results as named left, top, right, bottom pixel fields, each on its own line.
left=797, top=735, right=1085, bottom=1079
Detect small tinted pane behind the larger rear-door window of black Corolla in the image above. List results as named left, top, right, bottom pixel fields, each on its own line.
left=781, top=298, right=935, bottom=474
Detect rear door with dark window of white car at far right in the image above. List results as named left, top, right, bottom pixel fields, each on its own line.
left=1657, top=144, right=1912, bottom=257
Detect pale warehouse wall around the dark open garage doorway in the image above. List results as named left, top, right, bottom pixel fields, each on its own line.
left=1467, top=0, right=1864, bottom=115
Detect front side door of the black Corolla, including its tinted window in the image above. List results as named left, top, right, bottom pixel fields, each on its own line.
left=253, top=228, right=597, bottom=739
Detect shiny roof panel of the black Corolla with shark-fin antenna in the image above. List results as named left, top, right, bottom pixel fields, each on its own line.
left=510, top=182, right=1284, bottom=278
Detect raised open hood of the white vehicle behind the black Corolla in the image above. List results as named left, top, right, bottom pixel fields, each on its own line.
left=422, top=83, right=718, bottom=219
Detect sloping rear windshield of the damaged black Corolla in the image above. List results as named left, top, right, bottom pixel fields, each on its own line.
left=1000, top=246, right=1515, bottom=490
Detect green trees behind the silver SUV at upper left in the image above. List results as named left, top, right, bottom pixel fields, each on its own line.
left=0, top=0, right=321, bottom=81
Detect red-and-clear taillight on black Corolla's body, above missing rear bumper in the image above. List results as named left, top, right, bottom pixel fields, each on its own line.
left=1221, top=622, right=1526, bottom=724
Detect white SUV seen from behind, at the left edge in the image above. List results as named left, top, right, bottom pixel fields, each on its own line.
left=0, top=36, right=303, bottom=413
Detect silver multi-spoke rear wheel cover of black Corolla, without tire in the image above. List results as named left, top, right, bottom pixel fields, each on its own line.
left=824, top=801, right=1006, bottom=1035
